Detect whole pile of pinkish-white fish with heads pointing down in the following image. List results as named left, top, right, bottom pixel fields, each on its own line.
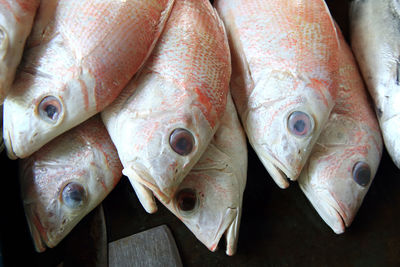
left=0, top=0, right=400, bottom=255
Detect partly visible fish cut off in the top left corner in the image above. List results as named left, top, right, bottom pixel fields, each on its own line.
left=0, top=0, right=40, bottom=104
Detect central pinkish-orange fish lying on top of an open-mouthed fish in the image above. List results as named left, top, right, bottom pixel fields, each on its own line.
left=101, top=0, right=231, bottom=206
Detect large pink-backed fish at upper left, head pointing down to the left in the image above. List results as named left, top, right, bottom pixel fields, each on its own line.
left=3, top=0, right=174, bottom=159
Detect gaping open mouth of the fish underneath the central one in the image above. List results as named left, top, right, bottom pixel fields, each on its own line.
left=205, top=208, right=241, bottom=256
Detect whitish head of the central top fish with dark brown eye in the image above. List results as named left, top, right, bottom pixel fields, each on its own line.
left=102, top=73, right=216, bottom=202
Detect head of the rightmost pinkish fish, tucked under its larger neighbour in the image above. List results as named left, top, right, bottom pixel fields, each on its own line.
left=298, top=114, right=382, bottom=234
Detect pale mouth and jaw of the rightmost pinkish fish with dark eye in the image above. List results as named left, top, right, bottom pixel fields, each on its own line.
left=299, top=182, right=351, bottom=234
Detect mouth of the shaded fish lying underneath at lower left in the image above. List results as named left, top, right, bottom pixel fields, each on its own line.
left=25, top=206, right=47, bottom=252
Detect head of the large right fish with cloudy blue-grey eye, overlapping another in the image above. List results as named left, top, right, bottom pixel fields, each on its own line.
left=247, top=70, right=334, bottom=188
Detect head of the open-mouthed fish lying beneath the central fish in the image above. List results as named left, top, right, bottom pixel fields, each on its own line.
left=163, top=144, right=242, bottom=255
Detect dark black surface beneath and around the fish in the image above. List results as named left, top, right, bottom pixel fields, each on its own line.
left=0, top=0, right=400, bottom=266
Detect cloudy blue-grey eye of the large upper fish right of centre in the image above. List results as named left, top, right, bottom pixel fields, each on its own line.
left=287, top=111, right=314, bottom=137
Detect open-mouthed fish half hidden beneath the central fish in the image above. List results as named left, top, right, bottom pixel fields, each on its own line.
left=145, top=95, right=248, bottom=256
